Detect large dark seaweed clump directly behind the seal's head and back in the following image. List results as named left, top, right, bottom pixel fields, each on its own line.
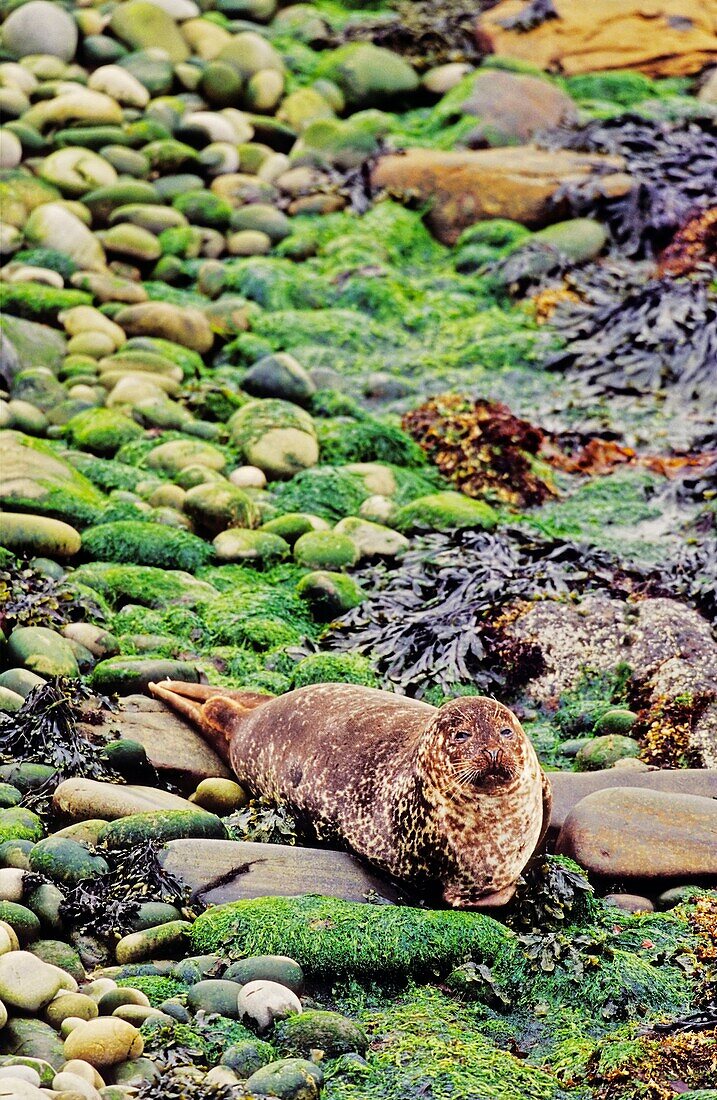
left=327, top=528, right=644, bottom=696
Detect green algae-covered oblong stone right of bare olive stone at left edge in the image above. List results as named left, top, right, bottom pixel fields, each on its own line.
left=82, top=519, right=212, bottom=573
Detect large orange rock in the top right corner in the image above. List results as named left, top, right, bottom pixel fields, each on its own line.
left=477, top=0, right=717, bottom=77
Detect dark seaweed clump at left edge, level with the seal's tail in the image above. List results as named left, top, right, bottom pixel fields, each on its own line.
left=0, top=677, right=118, bottom=782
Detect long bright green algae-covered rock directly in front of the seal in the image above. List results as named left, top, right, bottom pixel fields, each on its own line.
left=191, top=894, right=512, bottom=977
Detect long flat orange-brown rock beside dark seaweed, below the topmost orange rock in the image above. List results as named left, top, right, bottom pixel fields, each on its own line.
left=372, top=145, right=632, bottom=244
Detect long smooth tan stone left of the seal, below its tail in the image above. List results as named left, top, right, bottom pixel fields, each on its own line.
left=53, top=779, right=197, bottom=822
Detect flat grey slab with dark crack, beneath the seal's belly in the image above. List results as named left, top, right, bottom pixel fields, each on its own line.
left=163, top=840, right=399, bottom=905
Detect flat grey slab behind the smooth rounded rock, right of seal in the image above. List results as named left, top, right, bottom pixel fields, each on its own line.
left=549, top=768, right=717, bottom=839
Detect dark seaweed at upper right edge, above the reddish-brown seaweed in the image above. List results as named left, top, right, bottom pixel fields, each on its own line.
left=545, top=114, right=717, bottom=257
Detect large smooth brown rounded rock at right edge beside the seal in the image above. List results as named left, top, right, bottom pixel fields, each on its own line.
left=556, top=787, right=717, bottom=893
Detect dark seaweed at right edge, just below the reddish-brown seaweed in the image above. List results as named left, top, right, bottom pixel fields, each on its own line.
left=547, top=269, right=717, bottom=409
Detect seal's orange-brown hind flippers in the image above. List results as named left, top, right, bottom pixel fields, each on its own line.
left=150, top=680, right=274, bottom=762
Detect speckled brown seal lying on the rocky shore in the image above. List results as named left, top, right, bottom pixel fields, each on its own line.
left=150, top=681, right=551, bottom=908
